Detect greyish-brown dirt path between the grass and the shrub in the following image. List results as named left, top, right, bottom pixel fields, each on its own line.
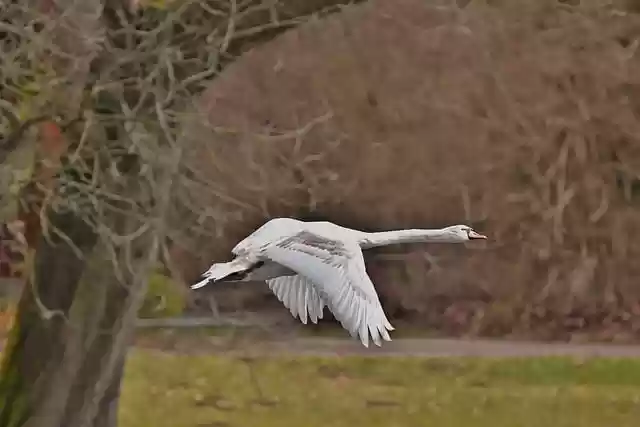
left=131, top=313, right=640, bottom=358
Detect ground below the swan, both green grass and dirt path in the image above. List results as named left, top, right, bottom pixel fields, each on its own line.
left=6, top=328, right=640, bottom=427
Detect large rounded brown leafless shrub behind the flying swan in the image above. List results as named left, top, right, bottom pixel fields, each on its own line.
left=176, top=0, right=640, bottom=340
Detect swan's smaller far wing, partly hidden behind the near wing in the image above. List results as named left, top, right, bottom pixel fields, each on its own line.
left=266, top=274, right=326, bottom=325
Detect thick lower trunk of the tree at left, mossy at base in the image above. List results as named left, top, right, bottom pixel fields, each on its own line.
left=0, top=205, right=156, bottom=427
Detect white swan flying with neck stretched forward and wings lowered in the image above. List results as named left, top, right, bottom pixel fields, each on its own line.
left=191, top=218, right=486, bottom=347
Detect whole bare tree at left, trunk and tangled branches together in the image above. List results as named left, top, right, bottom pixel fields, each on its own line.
left=0, top=0, right=364, bottom=427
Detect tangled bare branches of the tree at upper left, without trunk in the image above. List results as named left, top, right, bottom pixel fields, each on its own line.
left=0, top=0, right=370, bottom=342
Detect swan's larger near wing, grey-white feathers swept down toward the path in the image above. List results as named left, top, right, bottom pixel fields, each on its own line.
left=262, top=231, right=393, bottom=347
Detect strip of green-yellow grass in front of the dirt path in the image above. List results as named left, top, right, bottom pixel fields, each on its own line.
left=120, top=350, right=640, bottom=427
